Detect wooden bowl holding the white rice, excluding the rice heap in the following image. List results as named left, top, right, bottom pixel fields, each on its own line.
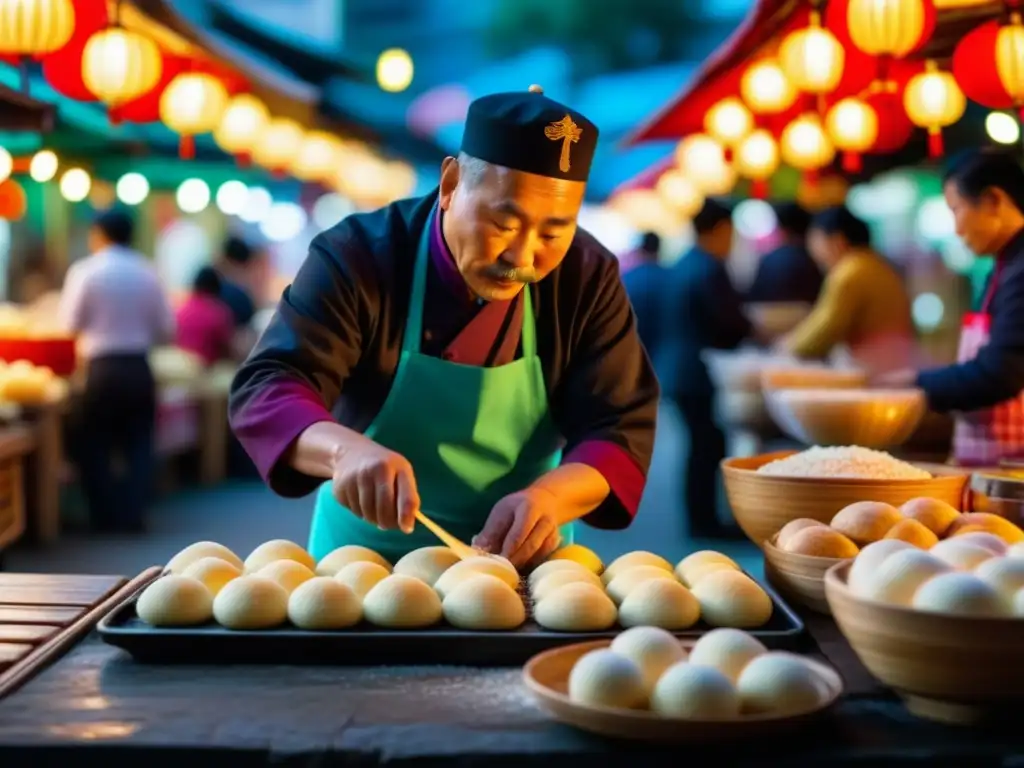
left=722, top=451, right=970, bottom=547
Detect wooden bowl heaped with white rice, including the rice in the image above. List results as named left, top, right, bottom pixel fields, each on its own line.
left=722, top=445, right=970, bottom=547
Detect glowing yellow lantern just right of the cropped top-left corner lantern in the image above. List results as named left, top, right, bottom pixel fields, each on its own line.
left=82, top=27, right=164, bottom=106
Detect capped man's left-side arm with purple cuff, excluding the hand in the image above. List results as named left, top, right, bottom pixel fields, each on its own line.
left=230, top=228, right=366, bottom=497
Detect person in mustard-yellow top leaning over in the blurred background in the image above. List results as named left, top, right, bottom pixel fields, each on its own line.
left=779, top=206, right=913, bottom=372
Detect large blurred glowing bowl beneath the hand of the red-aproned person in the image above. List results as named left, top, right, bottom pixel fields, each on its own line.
left=765, top=387, right=928, bottom=449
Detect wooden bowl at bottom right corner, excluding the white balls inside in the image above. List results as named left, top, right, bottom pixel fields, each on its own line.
left=825, top=562, right=1024, bottom=724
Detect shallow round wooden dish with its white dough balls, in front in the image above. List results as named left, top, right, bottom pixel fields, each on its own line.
left=523, top=627, right=843, bottom=742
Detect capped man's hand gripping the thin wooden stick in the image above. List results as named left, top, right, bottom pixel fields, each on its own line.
left=332, top=439, right=420, bottom=534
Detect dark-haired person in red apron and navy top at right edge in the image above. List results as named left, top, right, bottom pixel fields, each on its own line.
left=878, top=148, right=1024, bottom=466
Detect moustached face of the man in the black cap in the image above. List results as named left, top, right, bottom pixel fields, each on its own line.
left=440, top=158, right=586, bottom=301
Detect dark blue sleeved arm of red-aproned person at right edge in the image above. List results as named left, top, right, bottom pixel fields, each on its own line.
left=918, top=274, right=1024, bottom=413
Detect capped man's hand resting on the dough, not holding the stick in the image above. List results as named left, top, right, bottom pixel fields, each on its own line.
left=473, top=488, right=561, bottom=568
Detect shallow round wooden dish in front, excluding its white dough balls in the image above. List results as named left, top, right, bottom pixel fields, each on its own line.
left=522, top=640, right=843, bottom=742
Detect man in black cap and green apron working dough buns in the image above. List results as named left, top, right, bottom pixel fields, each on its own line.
left=230, top=87, right=658, bottom=566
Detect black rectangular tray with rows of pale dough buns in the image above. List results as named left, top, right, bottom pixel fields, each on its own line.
left=97, top=540, right=804, bottom=666
